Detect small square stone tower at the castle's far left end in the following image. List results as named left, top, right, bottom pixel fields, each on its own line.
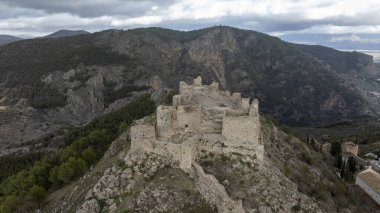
left=131, top=125, right=156, bottom=152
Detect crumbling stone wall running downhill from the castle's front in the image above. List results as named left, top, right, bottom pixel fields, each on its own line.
left=192, top=163, right=245, bottom=213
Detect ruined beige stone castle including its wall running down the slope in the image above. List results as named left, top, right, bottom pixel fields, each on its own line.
left=131, top=77, right=264, bottom=212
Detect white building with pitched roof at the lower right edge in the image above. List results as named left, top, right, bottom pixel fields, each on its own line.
left=355, top=168, right=380, bottom=205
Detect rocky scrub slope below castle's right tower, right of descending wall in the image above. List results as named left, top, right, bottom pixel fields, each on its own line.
left=200, top=154, right=322, bottom=213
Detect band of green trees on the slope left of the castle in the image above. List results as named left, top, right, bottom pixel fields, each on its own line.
left=0, top=95, right=155, bottom=212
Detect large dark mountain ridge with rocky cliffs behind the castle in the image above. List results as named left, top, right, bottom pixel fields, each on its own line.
left=0, top=27, right=379, bottom=149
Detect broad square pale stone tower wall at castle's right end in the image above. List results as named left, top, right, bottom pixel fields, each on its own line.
left=222, top=116, right=261, bottom=144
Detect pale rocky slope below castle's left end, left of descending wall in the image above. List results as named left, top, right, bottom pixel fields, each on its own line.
left=76, top=153, right=215, bottom=213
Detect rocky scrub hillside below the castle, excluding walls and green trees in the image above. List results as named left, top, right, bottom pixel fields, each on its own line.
left=39, top=115, right=378, bottom=213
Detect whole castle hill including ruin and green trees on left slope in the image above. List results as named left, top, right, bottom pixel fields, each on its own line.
left=0, top=80, right=378, bottom=213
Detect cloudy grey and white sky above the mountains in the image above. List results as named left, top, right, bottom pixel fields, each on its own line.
left=0, top=0, right=380, bottom=56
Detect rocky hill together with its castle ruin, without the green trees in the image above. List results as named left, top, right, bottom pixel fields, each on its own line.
left=43, top=77, right=377, bottom=213
